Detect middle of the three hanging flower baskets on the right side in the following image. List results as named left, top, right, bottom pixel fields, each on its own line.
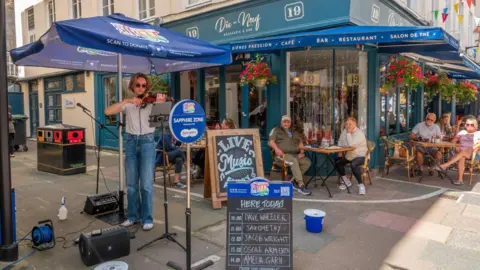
left=424, top=71, right=456, bottom=103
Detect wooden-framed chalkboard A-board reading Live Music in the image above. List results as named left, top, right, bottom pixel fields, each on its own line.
left=207, top=129, right=263, bottom=198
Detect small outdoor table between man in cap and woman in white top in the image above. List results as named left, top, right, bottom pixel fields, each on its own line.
left=299, top=146, right=355, bottom=198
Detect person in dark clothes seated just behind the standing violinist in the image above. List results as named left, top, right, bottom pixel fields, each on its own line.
left=155, top=132, right=185, bottom=189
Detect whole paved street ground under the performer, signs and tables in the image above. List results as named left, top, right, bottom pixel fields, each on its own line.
left=0, top=141, right=480, bottom=270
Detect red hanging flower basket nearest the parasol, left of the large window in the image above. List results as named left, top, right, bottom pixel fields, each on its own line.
left=240, top=54, right=277, bottom=88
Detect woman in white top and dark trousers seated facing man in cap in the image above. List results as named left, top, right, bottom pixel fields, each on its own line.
left=336, top=117, right=368, bottom=195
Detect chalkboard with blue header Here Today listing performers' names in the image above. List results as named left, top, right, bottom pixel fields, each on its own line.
left=226, top=178, right=293, bottom=270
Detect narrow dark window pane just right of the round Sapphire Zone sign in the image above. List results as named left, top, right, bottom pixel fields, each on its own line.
left=205, top=67, right=220, bottom=127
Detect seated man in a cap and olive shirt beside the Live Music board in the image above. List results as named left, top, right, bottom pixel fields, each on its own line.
left=268, top=115, right=312, bottom=195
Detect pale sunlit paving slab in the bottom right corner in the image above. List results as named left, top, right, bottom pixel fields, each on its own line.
left=420, top=241, right=480, bottom=270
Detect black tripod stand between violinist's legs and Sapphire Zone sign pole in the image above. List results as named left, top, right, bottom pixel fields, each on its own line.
left=137, top=109, right=187, bottom=251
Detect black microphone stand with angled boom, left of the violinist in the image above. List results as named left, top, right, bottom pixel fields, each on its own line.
left=77, top=106, right=125, bottom=225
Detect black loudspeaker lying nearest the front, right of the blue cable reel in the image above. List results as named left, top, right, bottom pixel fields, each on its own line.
left=78, top=227, right=130, bottom=266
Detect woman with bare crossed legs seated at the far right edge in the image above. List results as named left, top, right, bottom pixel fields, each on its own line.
left=435, top=116, right=480, bottom=185
